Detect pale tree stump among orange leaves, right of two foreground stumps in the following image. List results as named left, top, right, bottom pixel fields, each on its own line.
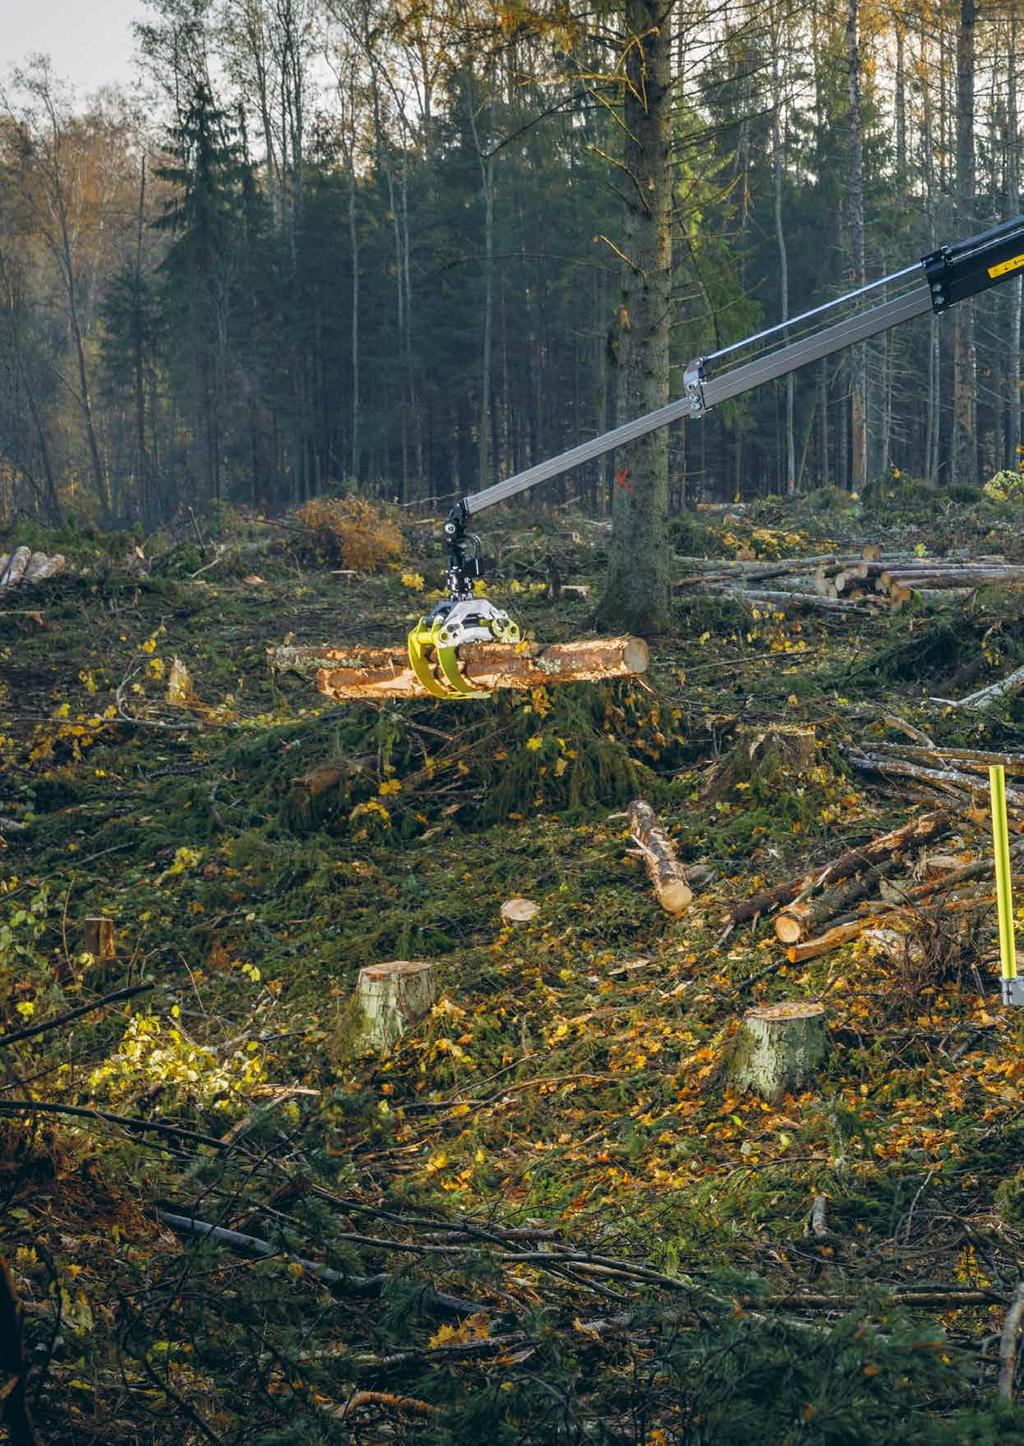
left=726, top=1001, right=829, bottom=1100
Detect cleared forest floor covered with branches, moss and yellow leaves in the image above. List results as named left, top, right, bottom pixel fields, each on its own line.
left=0, top=499, right=1024, bottom=1446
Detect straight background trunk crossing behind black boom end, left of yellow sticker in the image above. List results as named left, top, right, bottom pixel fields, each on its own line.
left=950, top=0, right=978, bottom=484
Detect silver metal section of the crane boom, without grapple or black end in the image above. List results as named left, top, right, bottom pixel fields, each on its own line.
left=461, top=262, right=934, bottom=516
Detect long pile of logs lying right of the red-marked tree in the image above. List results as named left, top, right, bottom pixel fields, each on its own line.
left=675, top=547, right=1024, bottom=610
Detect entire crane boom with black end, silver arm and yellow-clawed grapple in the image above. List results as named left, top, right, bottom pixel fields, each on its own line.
left=409, top=215, right=1024, bottom=697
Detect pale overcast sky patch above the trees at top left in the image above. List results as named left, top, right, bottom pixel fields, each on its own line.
left=0, top=0, right=152, bottom=95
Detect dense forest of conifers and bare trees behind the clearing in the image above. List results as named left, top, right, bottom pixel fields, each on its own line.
left=0, top=0, right=1021, bottom=529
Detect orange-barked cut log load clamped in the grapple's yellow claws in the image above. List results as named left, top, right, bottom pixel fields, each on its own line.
left=270, top=638, right=651, bottom=701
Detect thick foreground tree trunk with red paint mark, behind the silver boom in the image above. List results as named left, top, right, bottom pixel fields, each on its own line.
left=602, top=0, right=673, bottom=632
